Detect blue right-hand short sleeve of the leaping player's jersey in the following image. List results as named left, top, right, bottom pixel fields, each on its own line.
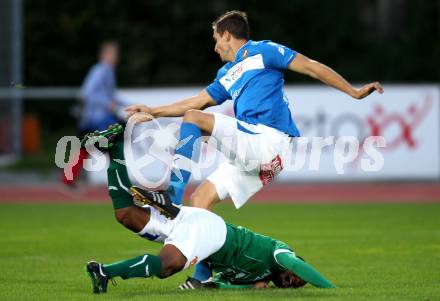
left=263, top=42, right=297, bottom=69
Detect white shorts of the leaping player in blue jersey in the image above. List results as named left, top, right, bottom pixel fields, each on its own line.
left=208, top=113, right=293, bottom=209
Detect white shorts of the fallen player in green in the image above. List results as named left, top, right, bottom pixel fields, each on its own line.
left=158, top=206, right=226, bottom=269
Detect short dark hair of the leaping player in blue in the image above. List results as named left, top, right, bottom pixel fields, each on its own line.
left=212, top=10, right=249, bottom=40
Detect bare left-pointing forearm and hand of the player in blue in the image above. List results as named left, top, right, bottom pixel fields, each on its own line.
left=125, top=90, right=217, bottom=123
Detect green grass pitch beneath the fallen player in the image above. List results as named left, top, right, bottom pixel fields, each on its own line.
left=0, top=204, right=440, bottom=301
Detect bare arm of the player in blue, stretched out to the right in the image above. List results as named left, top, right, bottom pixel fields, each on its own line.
left=288, top=53, right=383, bottom=99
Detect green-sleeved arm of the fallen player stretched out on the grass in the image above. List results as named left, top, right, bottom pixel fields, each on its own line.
left=275, top=252, right=336, bottom=288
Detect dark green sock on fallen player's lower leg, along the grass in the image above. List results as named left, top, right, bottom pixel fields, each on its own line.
left=102, top=254, right=162, bottom=279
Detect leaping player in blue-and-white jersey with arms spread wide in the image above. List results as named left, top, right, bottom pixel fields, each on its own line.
left=126, top=11, right=383, bottom=280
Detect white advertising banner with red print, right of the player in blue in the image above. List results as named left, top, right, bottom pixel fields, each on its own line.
left=281, top=85, right=440, bottom=180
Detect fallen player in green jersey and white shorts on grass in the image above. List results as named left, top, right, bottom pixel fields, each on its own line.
left=83, top=126, right=334, bottom=293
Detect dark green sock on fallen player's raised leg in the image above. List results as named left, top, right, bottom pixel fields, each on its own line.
left=107, top=139, right=133, bottom=209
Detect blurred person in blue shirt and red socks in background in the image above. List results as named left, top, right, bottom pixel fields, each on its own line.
left=61, top=41, right=119, bottom=186
